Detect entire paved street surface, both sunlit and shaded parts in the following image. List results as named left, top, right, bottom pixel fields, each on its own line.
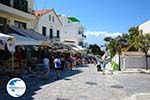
left=0, top=65, right=150, bottom=100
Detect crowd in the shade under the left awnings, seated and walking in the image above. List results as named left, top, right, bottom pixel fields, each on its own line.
left=11, top=47, right=82, bottom=79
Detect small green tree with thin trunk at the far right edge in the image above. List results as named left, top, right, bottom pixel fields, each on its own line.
left=134, top=32, right=150, bottom=69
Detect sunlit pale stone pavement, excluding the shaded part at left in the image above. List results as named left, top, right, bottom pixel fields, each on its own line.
left=33, top=65, right=150, bottom=100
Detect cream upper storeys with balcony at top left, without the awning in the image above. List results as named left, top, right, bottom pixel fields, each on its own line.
left=0, top=0, right=36, bottom=32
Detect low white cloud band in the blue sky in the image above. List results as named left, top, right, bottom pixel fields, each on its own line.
left=85, top=31, right=122, bottom=38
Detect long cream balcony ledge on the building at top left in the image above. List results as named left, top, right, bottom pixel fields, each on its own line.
left=0, top=3, right=36, bottom=21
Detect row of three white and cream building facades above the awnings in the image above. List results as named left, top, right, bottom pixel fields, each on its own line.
left=0, top=0, right=85, bottom=46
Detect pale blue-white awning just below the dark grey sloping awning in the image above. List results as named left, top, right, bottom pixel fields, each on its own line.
left=9, top=33, right=42, bottom=45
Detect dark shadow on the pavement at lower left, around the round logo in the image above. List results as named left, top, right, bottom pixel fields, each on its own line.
left=0, top=69, right=82, bottom=100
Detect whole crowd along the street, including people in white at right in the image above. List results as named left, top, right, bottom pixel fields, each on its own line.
left=0, top=46, right=113, bottom=79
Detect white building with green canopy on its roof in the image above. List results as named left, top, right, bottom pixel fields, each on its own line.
left=59, top=15, right=86, bottom=46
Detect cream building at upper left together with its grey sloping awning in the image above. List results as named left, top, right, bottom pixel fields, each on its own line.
left=0, top=0, right=49, bottom=45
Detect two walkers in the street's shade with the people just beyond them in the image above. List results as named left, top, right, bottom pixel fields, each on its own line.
left=43, top=52, right=82, bottom=79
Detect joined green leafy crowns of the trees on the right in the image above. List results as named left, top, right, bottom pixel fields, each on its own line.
left=104, top=27, right=150, bottom=56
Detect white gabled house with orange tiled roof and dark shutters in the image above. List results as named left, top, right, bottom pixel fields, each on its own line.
left=34, top=9, right=62, bottom=42
